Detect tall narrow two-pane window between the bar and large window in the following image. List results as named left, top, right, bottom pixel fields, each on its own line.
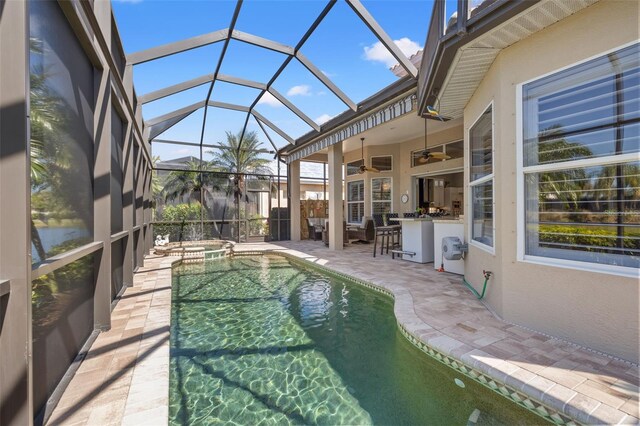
left=469, top=106, right=495, bottom=248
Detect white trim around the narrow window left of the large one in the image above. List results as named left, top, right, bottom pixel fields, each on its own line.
left=466, top=99, right=497, bottom=256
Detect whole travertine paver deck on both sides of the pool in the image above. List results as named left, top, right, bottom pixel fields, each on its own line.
left=50, top=241, right=640, bottom=425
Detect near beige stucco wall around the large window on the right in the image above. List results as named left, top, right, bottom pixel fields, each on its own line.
left=464, top=0, right=640, bottom=362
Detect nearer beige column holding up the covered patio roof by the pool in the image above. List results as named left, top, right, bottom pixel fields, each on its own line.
left=328, top=142, right=344, bottom=250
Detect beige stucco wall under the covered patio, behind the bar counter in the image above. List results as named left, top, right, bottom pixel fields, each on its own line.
left=343, top=117, right=463, bottom=221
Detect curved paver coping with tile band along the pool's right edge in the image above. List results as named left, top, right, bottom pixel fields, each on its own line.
left=231, top=248, right=636, bottom=426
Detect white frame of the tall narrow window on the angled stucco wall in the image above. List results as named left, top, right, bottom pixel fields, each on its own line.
left=466, top=100, right=496, bottom=255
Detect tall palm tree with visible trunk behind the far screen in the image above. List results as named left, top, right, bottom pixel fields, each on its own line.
left=207, top=131, right=271, bottom=241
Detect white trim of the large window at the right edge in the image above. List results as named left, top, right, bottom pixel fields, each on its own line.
left=516, top=45, right=640, bottom=278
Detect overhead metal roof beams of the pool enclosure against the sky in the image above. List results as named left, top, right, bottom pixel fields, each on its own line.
left=136, top=0, right=418, bottom=151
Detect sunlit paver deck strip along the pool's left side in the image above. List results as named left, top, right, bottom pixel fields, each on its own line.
left=48, top=256, right=179, bottom=426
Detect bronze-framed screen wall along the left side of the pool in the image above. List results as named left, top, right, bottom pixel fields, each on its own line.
left=0, top=0, right=158, bottom=424
